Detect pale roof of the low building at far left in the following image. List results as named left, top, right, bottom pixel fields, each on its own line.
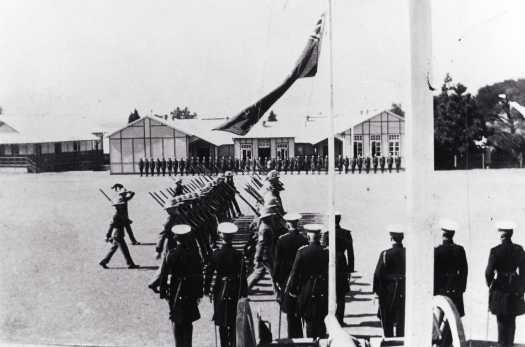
left=0, top=115, right=101, bottom=144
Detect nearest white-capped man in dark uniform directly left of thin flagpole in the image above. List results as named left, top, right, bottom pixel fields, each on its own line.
left=285, top=224, right=328, bottom=338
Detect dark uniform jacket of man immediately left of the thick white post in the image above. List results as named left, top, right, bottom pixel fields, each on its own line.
left=373, top=244, right=405, bottom=321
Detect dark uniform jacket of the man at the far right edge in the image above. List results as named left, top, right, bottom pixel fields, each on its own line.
left=485, top=241, right=525, bottom=316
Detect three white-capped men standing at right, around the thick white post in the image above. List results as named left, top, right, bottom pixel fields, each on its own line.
left=373, top=220, right=525, bottom=347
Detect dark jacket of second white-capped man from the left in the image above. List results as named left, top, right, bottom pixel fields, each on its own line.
left=204, top=244, right=248, bottom=326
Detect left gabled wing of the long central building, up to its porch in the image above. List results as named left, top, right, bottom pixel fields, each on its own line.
left=109, top=116, right=234, bottom=174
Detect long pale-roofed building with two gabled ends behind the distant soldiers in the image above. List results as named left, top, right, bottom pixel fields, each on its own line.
left=105, top=111, right=405, bottom=174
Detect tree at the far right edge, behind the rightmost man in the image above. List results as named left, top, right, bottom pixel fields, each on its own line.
left=476, top=79, right=525, bottom=165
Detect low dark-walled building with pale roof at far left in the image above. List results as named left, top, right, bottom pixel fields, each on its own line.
left=0, top=116, right=104, bottom=172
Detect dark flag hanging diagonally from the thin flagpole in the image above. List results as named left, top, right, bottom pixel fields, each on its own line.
left=213, top=14, right=325, bottom=135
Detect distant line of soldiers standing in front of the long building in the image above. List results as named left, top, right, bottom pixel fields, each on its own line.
left=137, top=155, right=401, bottom=176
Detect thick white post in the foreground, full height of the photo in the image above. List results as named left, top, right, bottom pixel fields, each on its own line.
left=404, top=0, right=435, bottom=347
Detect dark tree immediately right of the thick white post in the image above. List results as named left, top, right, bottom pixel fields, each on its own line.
left=434, top=74, right=486, bottom=169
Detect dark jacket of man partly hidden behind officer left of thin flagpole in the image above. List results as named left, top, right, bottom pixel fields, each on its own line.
left=273, top=231, right=308, bottom=312
